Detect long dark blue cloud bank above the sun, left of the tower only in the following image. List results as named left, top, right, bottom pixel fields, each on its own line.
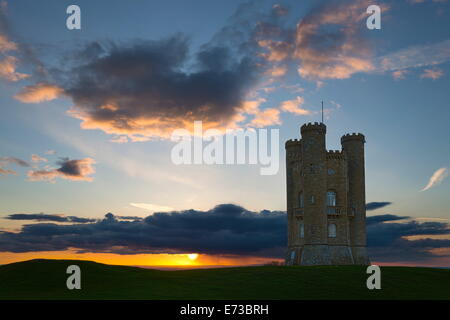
left=0, top=204, right=286, bottom=256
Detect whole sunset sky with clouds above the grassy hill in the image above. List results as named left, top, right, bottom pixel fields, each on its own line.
left=0, top=0, right=450, bottom=267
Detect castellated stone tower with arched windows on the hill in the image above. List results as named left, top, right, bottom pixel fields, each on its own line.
left=286, top=122, right=369, bottom=265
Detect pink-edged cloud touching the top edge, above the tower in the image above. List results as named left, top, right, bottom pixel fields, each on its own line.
left=294, top=0, right=374, bottom=80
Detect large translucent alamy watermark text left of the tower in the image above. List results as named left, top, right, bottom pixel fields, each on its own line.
left=171, top=121, right=280, bottom=175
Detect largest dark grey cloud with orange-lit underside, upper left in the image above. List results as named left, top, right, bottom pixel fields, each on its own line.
left=16, top=35, right=259, bottom=141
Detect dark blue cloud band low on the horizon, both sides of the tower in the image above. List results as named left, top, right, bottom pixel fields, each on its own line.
left=0, top=204, right=450, bottom=261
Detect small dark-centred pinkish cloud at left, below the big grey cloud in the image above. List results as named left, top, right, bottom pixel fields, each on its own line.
left=27, top=158, right=95, bottom=182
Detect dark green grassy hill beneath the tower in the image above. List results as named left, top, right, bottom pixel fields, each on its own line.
left=0, top=260, right=450, bottom=300
